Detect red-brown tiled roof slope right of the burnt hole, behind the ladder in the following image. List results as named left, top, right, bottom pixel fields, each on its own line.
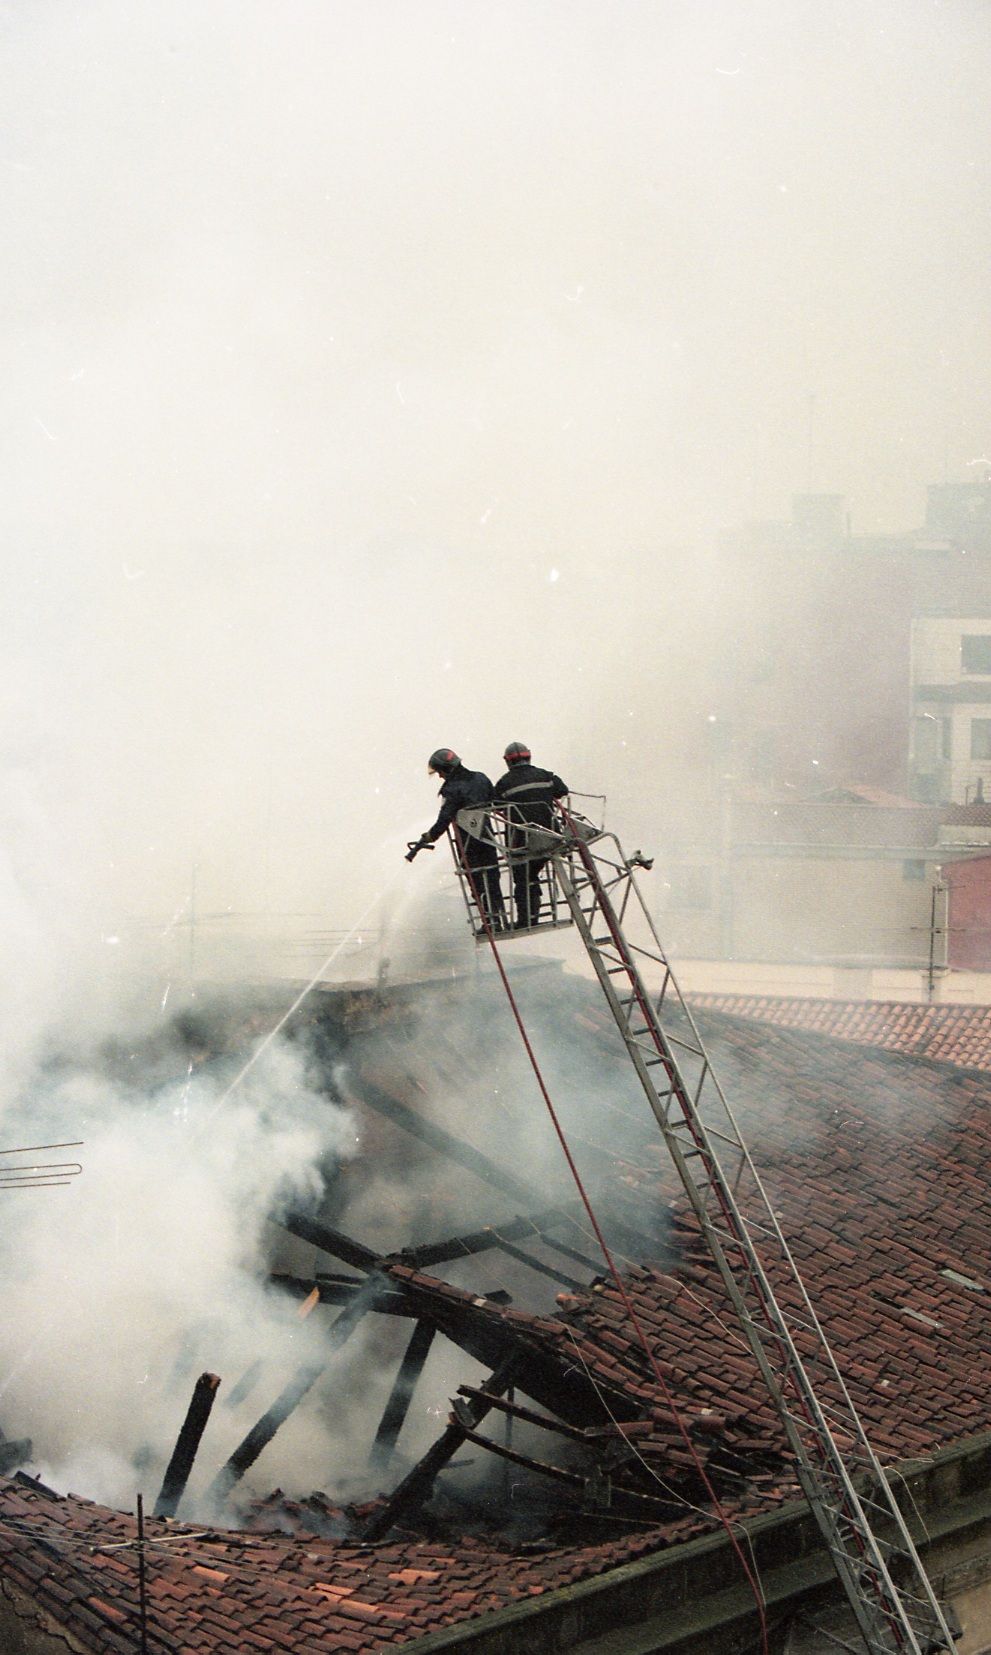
left=372, top=1013, right=991, bottom=1494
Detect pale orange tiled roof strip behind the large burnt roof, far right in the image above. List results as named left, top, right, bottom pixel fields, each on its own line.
left=692, top=995, right=991, bottom=1069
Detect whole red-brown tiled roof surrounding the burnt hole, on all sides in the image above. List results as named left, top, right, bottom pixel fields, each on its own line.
left=9, top=1001, right=991, bottom=1655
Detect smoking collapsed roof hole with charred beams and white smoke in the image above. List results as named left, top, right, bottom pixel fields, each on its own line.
left=2, top=965, right=807, bottom=1544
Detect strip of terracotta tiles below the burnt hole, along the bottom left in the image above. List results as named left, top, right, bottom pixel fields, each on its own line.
left=0, top=1475, right=698, bottom=1655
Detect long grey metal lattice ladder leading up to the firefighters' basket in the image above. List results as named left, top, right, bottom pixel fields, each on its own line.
left=553, top=846, right=948, bottom=1648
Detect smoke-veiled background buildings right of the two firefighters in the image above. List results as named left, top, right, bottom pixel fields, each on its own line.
left=658, top=473, right=991, bottom=988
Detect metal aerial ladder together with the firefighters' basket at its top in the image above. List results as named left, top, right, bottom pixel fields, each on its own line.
left=450, top=803, right=955, bottom=1655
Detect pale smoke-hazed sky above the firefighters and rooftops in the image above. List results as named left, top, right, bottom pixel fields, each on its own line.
left=0, top=0, right=991, bottom=953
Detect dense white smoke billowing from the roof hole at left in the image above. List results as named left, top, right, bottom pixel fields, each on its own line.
left=0, top=1044, right=356, bottom=1504
